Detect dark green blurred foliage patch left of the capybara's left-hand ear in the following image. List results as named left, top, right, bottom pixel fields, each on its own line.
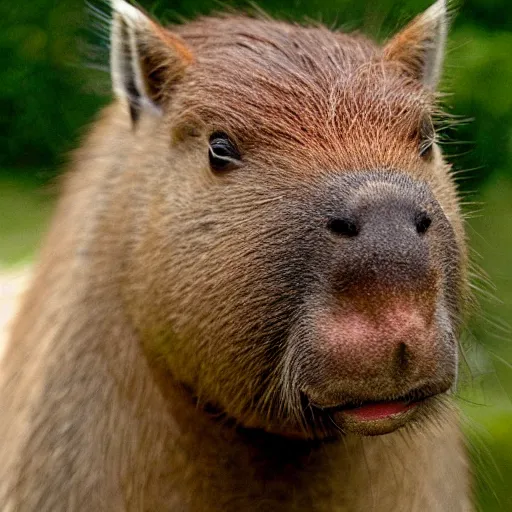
left=0, top=0, right=107, bottom=178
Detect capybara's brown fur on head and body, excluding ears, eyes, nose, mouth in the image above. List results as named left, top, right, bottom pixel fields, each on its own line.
left=0, top=5, right=471, bottom=512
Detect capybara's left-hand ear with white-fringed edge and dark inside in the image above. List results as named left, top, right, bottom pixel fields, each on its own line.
left=110, top=0, right=194, bottom=125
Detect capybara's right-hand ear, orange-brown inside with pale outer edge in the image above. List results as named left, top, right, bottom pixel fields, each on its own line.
left=384, top=0, right=449, bottom=91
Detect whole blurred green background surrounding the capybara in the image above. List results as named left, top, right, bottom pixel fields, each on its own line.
left=0, top=0, right=512, bottom=511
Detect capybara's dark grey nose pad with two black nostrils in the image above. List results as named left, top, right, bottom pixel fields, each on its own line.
left=326, top=173, right=443, bottom=293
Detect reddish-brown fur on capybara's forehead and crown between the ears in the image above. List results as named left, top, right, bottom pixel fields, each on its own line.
left=169, top=17, right=435, bottom=171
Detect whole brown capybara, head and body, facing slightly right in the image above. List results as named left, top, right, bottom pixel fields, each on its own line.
left=0, top=0, right=472, bottom=512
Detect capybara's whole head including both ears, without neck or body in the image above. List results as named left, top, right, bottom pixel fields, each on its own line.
left=112, top=0, right=465, bottom=438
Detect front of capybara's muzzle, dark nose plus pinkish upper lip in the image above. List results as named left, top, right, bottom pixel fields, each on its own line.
left=308, top=172, right=448, bottom=396
